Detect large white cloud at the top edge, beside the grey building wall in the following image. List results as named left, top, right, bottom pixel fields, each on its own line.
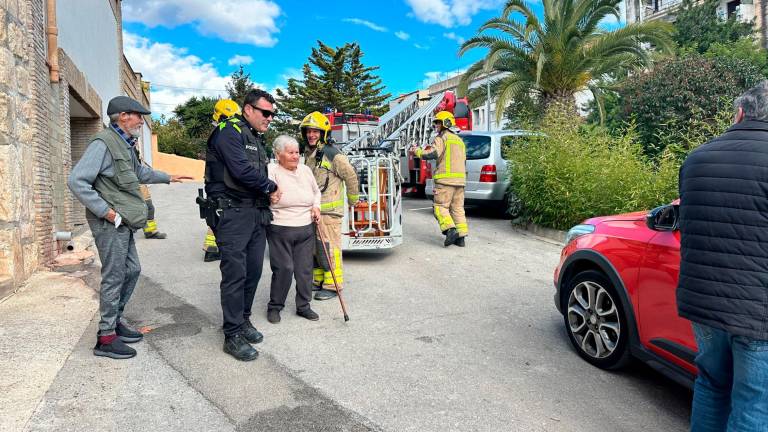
left=122, top=0, right=281, bottom=47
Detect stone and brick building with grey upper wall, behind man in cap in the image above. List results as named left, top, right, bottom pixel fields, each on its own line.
left=0, top=0, right=151, bottom=298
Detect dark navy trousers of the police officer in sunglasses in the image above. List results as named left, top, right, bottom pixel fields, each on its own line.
left=213, top=207, right=269, bottom=336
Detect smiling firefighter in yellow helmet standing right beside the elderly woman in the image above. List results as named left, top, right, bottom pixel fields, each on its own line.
left=299, top=111, right=360, bottom=300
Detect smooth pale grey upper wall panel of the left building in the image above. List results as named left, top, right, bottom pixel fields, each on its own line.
left=56, top=0, right=119, bottom=119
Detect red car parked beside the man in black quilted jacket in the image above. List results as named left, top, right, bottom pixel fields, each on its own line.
left=555, top=202, right=696, bottom=387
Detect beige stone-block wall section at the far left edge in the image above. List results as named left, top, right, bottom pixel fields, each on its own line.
left=0, top=0, right=44, bottom=297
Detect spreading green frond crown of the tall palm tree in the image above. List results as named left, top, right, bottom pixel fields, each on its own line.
left=458, top=0, right=674, bottom=122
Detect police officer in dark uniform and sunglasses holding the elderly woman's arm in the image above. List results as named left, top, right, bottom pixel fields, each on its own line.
left=205, top=89, right=279, bottom=361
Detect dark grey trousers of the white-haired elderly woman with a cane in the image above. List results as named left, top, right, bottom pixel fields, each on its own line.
left=267, top=224, right=315, bottom=311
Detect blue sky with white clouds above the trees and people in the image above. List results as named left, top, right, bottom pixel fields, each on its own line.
left=122, top=0, right=624, bottom=117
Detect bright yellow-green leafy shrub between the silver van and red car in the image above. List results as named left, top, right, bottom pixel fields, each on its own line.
left=507, top=113, right=679, bottom=229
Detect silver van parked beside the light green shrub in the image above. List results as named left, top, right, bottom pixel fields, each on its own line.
left=425, top=130, right=534, bottom=212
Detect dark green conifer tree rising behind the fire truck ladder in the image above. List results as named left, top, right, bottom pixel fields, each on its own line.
left=277, top=41, right=390, bottom=119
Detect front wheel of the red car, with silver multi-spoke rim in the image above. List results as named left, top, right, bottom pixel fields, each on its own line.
left=563, top=270, right=630, bottom=370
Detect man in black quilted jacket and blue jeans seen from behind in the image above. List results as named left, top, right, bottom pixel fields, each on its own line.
left=677, top=81, right=768, bottom=431
